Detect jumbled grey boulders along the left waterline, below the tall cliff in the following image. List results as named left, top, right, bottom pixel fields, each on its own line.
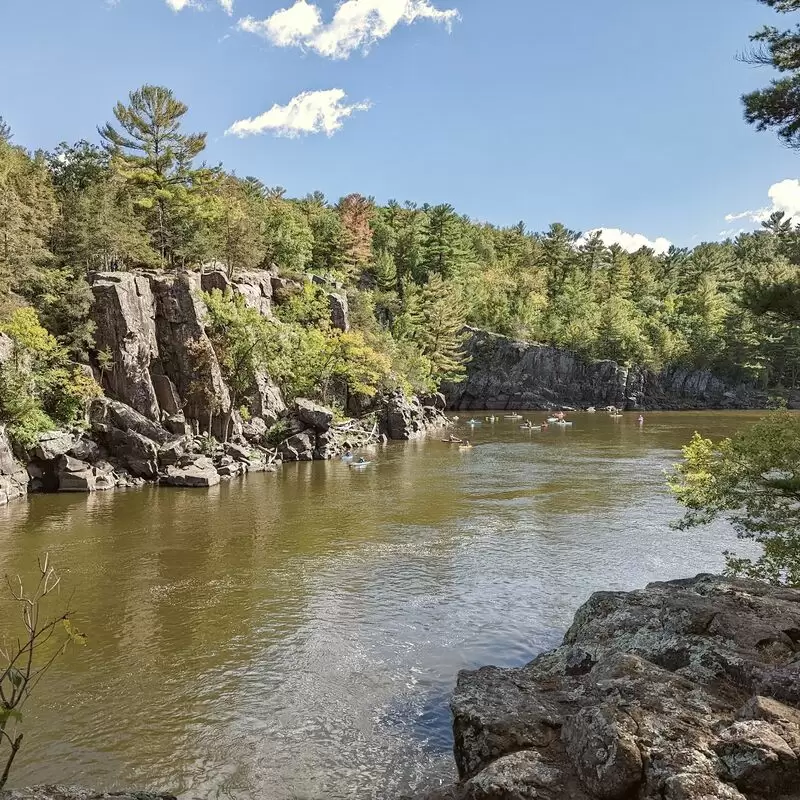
left=0, top=393, right=450, bottom=505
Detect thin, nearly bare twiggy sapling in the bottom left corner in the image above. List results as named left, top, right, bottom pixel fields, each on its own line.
left=0, top=555, right=86, bottom=789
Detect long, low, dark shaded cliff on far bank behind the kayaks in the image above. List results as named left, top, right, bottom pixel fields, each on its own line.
left=445, top=329, right=780, bottom=410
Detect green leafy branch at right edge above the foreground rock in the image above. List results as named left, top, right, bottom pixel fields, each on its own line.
left=668, top=412, right=800, bottom=586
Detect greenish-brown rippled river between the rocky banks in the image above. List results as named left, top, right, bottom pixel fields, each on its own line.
left=0, top=412, right=760, bottom=800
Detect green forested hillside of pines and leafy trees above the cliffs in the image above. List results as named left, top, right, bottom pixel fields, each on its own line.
left=0, top=86, right=800, bottom=446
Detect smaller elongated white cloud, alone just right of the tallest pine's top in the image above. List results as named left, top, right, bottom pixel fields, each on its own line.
left=225, top=89, right=371, bottom=139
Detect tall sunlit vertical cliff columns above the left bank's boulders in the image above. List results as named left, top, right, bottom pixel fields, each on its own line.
left=92, top=271, right=285, bottom=438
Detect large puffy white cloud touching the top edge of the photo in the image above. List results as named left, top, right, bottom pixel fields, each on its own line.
left=238, top=0, right=459, bottom=58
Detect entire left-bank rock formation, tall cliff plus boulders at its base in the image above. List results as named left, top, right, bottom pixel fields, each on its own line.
left=0, top=270, right=449, bottom=505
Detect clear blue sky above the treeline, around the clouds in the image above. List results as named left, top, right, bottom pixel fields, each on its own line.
left=0, top=0, right=800, bottom=250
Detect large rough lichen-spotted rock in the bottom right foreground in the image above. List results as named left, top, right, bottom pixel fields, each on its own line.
left=429, top=575, right=800, bottom=800
